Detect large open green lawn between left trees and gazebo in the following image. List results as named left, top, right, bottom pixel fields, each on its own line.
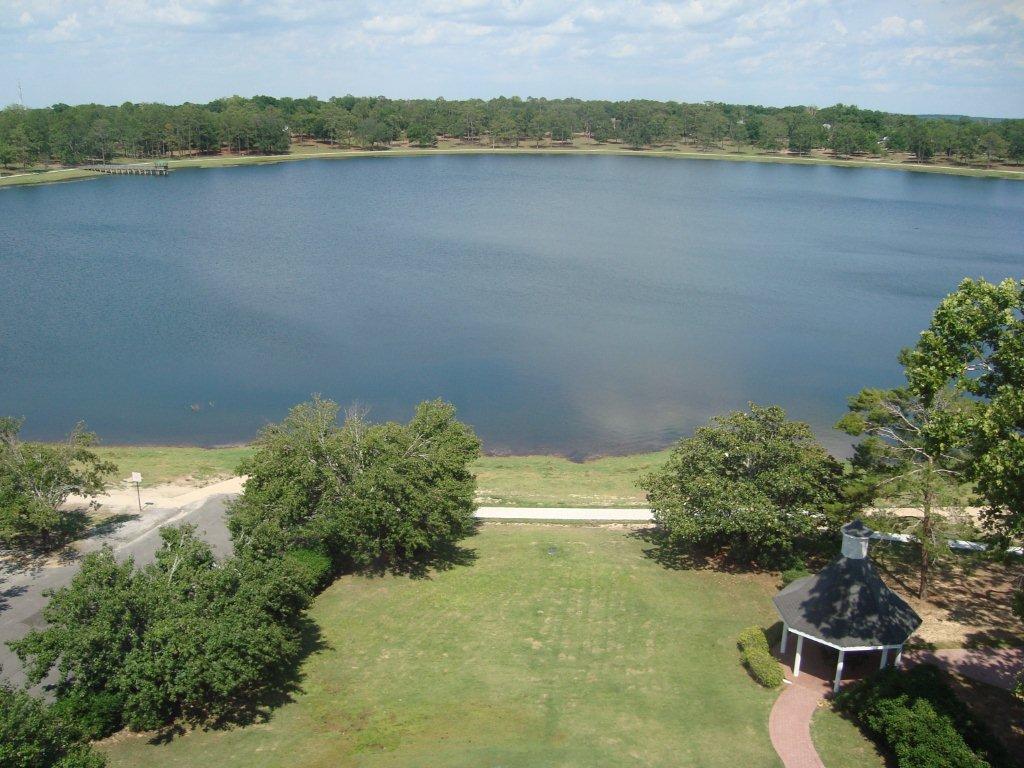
left=101, top=524, right=780, bottom=768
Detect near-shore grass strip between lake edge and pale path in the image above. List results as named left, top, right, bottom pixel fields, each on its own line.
left=92, top=446, right=668, bottom=507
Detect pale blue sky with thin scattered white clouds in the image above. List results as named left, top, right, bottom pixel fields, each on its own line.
left=0, top=0, right=1024, bottom=117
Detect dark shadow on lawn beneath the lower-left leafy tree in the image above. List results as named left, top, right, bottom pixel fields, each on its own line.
left=148, top=615, right=331, bottom=744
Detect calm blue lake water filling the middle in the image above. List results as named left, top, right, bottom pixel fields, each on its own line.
left=0, top=156, right=1024, bottom=457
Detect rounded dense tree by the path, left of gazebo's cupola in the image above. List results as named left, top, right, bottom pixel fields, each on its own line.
left=640, top=403, right=843, bottom=566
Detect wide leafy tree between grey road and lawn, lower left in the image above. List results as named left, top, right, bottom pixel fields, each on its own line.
left=10, top=526, right=312, bottom=737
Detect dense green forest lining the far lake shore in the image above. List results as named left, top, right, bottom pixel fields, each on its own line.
left=0, top=96, right=1024, bottom=167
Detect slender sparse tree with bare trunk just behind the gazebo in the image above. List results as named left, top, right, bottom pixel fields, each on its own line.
left=836, top=388, right=969, bottom=600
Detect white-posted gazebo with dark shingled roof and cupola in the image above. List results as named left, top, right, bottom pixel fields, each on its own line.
left=773, top=520, right=921, bottom=691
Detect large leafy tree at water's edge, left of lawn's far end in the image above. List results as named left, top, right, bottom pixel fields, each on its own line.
left=228, top=398, right=480, bottom=565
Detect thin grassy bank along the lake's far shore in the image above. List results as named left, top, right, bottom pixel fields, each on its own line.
left=0, top=137, right=1024, bottom=186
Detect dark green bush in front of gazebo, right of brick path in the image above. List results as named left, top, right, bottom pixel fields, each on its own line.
left=836, top=665, right=1013, bottom=768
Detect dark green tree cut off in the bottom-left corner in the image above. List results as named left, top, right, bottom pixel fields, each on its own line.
left=0, top=684, right=106, bottom=768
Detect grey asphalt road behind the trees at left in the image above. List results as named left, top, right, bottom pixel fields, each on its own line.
left=0, top=496, right=231, bottom=686
